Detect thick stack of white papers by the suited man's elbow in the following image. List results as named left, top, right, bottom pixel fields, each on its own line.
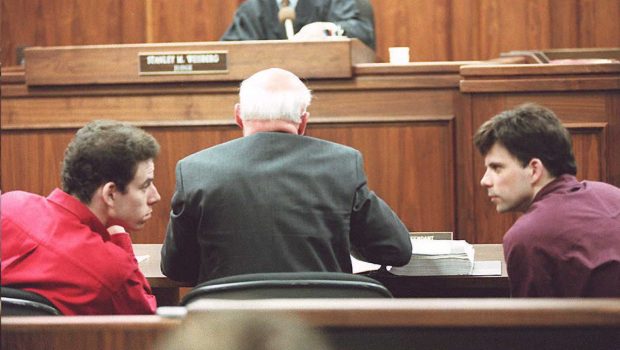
left=389, top=239, right=474, bottom=276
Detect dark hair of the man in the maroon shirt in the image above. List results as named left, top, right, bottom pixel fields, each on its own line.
left=474, top=103, right=577, bottom=177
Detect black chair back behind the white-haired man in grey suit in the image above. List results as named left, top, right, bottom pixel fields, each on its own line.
left=181, top=272, right=392, bottom=306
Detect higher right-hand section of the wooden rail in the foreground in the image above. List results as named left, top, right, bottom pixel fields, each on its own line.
left=189, top=298, right=620, bottom=350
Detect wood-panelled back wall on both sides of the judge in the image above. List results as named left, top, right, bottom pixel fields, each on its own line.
left=0, top=0, right=620, bottom=66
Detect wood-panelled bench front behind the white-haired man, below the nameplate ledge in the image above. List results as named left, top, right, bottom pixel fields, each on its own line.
left=0, top=63, right=459, bottom=243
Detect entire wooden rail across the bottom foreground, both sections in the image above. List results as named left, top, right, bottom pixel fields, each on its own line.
left=1, top=298, right=620, bottom=350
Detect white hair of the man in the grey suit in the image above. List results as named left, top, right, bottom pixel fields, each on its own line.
left=239, top=69, right=312, bottom=123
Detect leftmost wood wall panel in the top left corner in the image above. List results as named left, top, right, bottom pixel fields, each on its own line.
left=1, top=0, right=146, bottom=66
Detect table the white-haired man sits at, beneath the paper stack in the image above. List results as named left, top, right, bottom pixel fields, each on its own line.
left=133, top=244, right=509, bottom=305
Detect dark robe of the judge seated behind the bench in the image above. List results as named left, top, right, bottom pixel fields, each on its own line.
left=220, top=0, right=375, bottom=49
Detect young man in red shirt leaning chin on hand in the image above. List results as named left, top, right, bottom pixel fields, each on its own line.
left=0, top=121, right=161, bottom=315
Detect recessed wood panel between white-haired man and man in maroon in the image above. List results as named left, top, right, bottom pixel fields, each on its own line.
left=308, top=119, right=454, bottom=231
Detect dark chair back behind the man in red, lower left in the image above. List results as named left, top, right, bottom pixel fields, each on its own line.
left=0, top=286, right=61, bottom=316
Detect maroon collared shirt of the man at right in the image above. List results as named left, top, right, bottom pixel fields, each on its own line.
left=503, top=175, right=620, bottom=297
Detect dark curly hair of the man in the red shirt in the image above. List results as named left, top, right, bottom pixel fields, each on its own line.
left=61, top=120, right=159, bottom=204
